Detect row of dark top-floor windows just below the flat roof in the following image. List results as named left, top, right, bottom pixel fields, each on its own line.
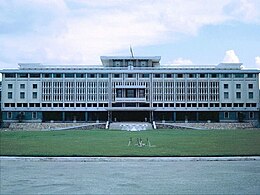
left=4, top=73, right=256, bottom=78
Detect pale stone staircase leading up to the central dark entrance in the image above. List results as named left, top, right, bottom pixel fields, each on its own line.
left=109, top=122, right=153, bottom=131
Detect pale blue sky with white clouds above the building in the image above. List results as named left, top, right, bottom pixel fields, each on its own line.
left=0, top=0, right=260, bottom=69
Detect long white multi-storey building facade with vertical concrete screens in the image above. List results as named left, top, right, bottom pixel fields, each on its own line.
left=1, top=56, right=259, bottom=122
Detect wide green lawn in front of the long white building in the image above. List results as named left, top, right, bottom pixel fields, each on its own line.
left=0, top=130, right=260, bottom=156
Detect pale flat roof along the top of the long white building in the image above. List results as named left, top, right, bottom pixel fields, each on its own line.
left=0, top=56, right=260, bottom=73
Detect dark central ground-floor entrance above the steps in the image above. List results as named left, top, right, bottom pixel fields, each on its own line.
left=112, top=111, right=150, bottom=122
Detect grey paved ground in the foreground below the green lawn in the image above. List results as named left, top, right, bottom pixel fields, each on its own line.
left=0, top=158, right=260, bottom=194
